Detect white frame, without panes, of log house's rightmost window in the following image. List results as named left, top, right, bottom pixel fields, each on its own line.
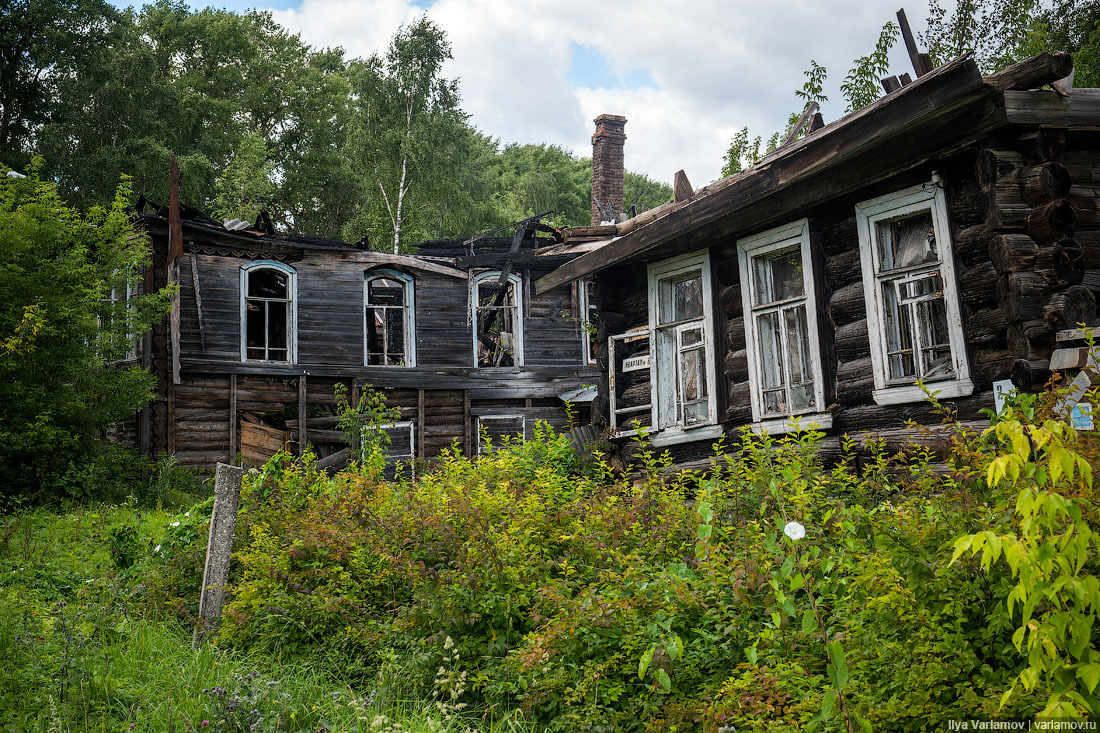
left=856, top=173, right=975, bottom=405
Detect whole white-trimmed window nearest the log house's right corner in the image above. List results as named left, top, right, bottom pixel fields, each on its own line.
left=856, top=175, right=974, bottom=405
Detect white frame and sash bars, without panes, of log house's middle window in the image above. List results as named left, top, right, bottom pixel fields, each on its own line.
left=737, top=219, right=833, bottom=434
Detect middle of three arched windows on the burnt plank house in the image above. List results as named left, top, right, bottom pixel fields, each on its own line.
left=363, top=270, right=416, bottom=367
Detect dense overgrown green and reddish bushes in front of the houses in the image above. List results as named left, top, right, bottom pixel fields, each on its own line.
left=155, top=385, right=1100, bottom=731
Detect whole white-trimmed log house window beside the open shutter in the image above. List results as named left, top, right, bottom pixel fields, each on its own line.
left=649, top=251, right=717, bottom=431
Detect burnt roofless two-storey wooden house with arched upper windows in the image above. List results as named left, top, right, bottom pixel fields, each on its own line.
left=117, top=185, right=596, bottom=468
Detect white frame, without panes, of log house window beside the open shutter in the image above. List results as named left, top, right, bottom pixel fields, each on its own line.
left=648, top=250, right=722, bottom=446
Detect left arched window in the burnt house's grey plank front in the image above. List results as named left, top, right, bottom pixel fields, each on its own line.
left=241, top=261, right=297, bottom=363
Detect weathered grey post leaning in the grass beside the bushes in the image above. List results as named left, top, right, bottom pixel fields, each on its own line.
left=191, top=463, right=243, bottom=648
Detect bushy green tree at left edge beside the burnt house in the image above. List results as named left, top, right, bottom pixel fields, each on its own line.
left=0, top=163, right=167, bottom=499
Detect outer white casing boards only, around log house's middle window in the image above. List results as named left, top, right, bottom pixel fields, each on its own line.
left=737, top=219, right=825, bottom=422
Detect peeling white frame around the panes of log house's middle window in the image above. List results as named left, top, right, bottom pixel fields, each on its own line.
left=737, top=219, right=833, bottom=434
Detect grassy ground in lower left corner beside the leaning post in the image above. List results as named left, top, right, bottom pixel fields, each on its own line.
left=0, top=506, right=523, bottom=733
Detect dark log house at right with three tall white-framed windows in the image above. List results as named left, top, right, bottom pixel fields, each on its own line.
left=536, top=48, right=1100, bottom=463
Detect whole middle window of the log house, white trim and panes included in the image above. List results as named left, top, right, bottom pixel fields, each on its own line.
left=737, top=219, right=832, bottom=433
